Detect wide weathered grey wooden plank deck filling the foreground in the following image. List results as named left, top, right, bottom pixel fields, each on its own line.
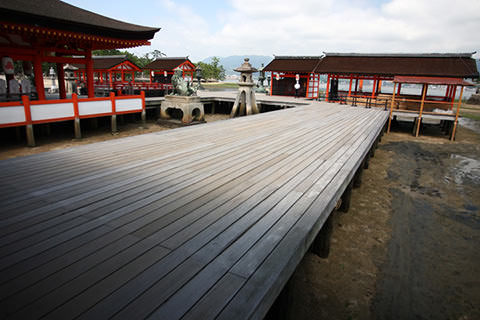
left=0, top=102, right=388, bottom=320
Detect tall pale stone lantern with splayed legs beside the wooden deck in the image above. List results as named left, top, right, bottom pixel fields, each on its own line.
left=230, top=58, right=259, bottom=118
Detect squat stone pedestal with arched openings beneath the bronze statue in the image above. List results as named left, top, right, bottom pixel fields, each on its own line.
left=160, top=95, right=205, bottom=124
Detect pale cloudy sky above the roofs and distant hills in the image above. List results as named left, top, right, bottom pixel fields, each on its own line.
left=66, top=0, right=480, bottom=62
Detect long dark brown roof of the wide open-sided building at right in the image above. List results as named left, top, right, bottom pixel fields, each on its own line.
left=315, top=53, right=478, bottom=78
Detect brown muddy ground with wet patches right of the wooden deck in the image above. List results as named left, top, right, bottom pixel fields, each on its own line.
left=287, top=120, right=480, bottom=320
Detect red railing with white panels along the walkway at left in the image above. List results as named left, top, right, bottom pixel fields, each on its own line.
left=0, top=91, right=146, bottom=147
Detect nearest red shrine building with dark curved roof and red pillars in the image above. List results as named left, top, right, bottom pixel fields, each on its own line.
left=0, top=0, right=160, bottom=100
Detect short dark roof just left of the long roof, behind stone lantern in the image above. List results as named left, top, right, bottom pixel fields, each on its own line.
left=263, top=56, right=321, bottom=73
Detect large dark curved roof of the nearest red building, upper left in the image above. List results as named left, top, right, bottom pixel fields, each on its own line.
left=0, top=0, right=160, bottom=40
